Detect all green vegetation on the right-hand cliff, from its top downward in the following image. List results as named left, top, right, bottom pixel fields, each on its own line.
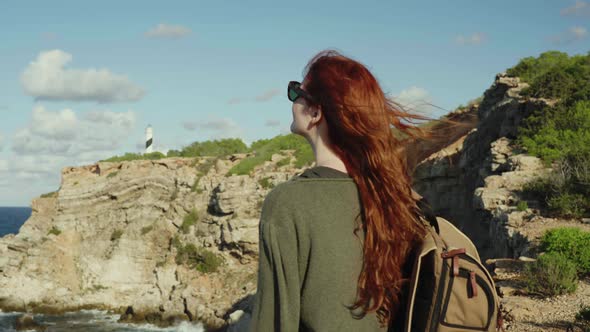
left=507, top=51, right=590, bottom=217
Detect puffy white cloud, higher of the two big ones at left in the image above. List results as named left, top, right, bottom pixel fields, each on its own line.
left=20, top=50, right=144, bottom=103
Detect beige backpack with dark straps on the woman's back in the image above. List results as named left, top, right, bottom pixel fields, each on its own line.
left=390, top=199, right=503, bottom=332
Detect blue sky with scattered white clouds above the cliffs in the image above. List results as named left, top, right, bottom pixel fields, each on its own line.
left=0, top=0, right=590, bottom=206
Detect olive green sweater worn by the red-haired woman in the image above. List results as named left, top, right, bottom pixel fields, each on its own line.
left=250, top=166, right=387, bottom=332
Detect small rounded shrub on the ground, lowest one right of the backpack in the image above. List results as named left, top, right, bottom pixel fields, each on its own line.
left=524, top=252, right=578, bottom=296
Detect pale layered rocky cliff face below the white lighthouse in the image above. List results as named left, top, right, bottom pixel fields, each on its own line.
left=0, top=151, right=300, bottom=326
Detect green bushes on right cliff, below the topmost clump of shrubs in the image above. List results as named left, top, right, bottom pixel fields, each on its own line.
left=518, top=101, right=590, bottom=217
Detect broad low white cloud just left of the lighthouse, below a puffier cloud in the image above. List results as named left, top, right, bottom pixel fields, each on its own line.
left=12, top=106, right=135, bottom=157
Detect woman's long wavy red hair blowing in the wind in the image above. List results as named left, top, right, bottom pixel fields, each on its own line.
left=303, top=50, right=474, bottom=325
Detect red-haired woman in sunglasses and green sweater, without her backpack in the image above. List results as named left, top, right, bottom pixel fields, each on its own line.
left=251, top=51, right=462, bottom=332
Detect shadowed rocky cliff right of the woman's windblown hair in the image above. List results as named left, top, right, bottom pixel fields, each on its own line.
left=415, top=74, right=572, bottom=258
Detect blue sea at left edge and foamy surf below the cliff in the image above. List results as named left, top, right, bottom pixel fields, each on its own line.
left=0, top=207, right=205, bottom=332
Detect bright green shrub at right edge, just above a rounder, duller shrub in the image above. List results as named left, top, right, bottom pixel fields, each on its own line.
left=541, top=227, right=590, bottom=274
